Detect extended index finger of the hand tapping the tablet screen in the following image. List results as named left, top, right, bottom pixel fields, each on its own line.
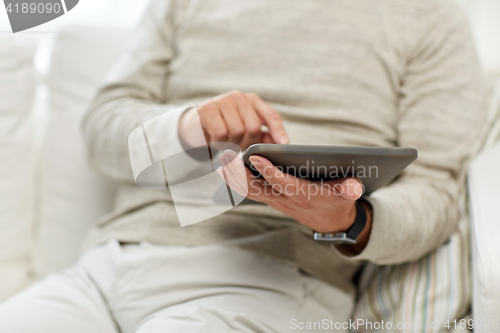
left=247, top=93, right=290, bottom=144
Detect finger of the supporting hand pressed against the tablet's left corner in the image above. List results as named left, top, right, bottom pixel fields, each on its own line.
left=250, top=155, right=298, bottom=195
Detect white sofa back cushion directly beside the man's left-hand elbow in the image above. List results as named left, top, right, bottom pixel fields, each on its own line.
left=34, top=26, right=128, bottom=277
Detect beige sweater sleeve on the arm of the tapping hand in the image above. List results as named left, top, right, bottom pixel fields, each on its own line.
left=83, top=0, right=203, bottom=183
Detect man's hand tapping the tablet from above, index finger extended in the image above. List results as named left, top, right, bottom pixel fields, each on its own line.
left=179, top=91, right=289, bottom=150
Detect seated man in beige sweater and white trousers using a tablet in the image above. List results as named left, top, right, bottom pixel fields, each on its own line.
left=0, top=0, right=485, bottom=332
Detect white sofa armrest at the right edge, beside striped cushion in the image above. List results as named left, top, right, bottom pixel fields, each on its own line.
left=468, top=144, right=500, bottom=332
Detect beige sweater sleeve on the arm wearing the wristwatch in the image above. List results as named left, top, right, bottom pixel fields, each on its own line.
left=338, top=1, right=486, bottom=265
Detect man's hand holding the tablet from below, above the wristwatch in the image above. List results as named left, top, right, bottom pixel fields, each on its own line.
left=219, top=150, right=371, bottom=254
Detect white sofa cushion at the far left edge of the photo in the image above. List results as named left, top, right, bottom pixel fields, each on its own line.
left=0, top=35, right=36, bottom=299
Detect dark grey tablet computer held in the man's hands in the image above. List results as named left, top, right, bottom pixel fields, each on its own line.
left=243, top=144, right=418, bottom=194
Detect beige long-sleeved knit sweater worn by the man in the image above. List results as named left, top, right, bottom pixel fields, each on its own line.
left=84, top=0, right=485, bottom=289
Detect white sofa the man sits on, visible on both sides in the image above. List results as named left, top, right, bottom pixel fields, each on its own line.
left=0, top=2, right=500, bottom=322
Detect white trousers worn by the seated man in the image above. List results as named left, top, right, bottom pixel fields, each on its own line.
left=0, top=241, right=354, bottom=333
